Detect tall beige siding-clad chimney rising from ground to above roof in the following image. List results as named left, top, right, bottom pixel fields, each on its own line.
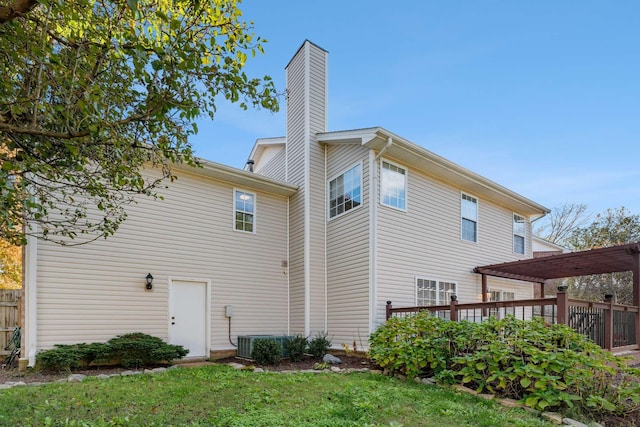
left=286, top=42, right=327, bottom=335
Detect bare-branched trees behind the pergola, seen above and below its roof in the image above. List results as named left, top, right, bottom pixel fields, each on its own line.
left=566, top=207, right=640, bottom=305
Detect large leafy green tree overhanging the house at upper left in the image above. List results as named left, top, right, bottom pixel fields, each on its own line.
left=0, top=0, right=278, bottom=244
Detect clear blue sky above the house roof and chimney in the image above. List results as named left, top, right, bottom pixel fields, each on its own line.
left=192, top=0, right=640, bottom=214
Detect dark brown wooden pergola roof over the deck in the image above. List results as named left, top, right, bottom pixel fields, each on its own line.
left=473, top=242, right=640, bottom=283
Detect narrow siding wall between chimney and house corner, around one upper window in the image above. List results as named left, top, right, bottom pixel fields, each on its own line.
left=327, top=144, right=370, bottom=347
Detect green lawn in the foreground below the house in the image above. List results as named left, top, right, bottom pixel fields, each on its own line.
left=0, top=366, right=550, bottom=427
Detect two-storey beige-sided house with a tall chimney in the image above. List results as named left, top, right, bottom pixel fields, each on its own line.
left=22, top=41, right=548, bottom=364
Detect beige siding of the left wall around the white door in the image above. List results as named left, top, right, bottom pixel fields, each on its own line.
left=38, top=171, right=287, bottom=350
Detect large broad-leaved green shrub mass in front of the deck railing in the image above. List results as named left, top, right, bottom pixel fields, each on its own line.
left=370, top=313, right=640, bottom=422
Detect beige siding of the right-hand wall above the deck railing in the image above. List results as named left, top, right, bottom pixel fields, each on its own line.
left=377, top=159, right=533, bottom=330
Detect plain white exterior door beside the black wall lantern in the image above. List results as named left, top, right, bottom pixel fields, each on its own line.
left=169, top=280, right=209, bottom=357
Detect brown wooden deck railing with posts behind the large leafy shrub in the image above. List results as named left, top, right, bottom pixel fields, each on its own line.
left=386, top=292, right=640, bottom=350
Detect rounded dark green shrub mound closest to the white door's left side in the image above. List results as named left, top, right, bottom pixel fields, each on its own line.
left=107, top=332, right=189, bottom=368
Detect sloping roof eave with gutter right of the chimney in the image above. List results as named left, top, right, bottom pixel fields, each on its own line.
left=317, top=127, right=550, bottom=216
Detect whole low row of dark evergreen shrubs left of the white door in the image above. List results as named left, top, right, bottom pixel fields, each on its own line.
left=37, top=332, right=188, bottom=371
